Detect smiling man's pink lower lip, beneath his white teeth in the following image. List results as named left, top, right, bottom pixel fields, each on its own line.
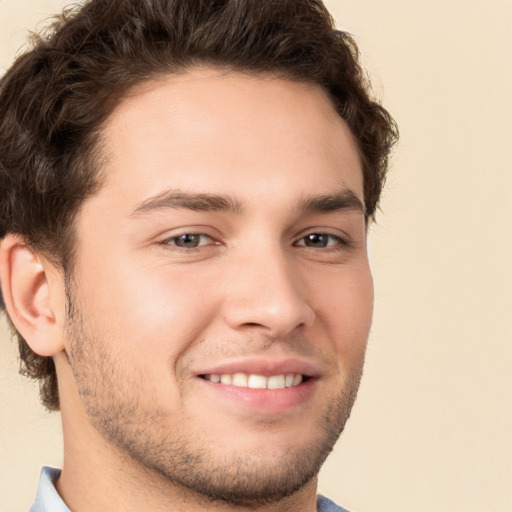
left=197, top=377, right=316, bottom=414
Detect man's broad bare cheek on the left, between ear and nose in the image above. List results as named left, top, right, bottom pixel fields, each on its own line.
left=74, top=252, right=219, bottom=362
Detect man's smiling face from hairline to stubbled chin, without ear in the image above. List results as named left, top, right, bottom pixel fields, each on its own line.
left=67, top=69, right=372, bottom=505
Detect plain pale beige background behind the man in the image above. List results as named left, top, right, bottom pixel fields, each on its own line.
left=0, top=0, right=512, bottom=512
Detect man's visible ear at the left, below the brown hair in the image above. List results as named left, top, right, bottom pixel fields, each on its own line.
left=0, top=234, right=65, bottom=356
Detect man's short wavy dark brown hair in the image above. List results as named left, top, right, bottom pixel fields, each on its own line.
left=0, top=0, right=397, bottom=410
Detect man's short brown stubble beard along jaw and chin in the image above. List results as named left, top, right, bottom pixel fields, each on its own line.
left=67, top=300, right=363, bottom=509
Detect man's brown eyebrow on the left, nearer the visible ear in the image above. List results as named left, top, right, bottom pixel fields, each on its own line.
left=130, top=190, right=242, bottom=218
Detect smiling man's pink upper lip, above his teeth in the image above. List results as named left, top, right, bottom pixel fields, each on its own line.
left=195, top=358, right=320, bottom=377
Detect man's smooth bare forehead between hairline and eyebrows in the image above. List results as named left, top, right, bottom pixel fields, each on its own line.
left=95, top=68, right=363, bottom=210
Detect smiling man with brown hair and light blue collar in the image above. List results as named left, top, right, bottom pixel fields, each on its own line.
left=0, top=0, right=396, bottom=512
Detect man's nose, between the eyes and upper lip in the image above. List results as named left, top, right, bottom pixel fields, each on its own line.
left=223, top=249, right=315, bottom=338
